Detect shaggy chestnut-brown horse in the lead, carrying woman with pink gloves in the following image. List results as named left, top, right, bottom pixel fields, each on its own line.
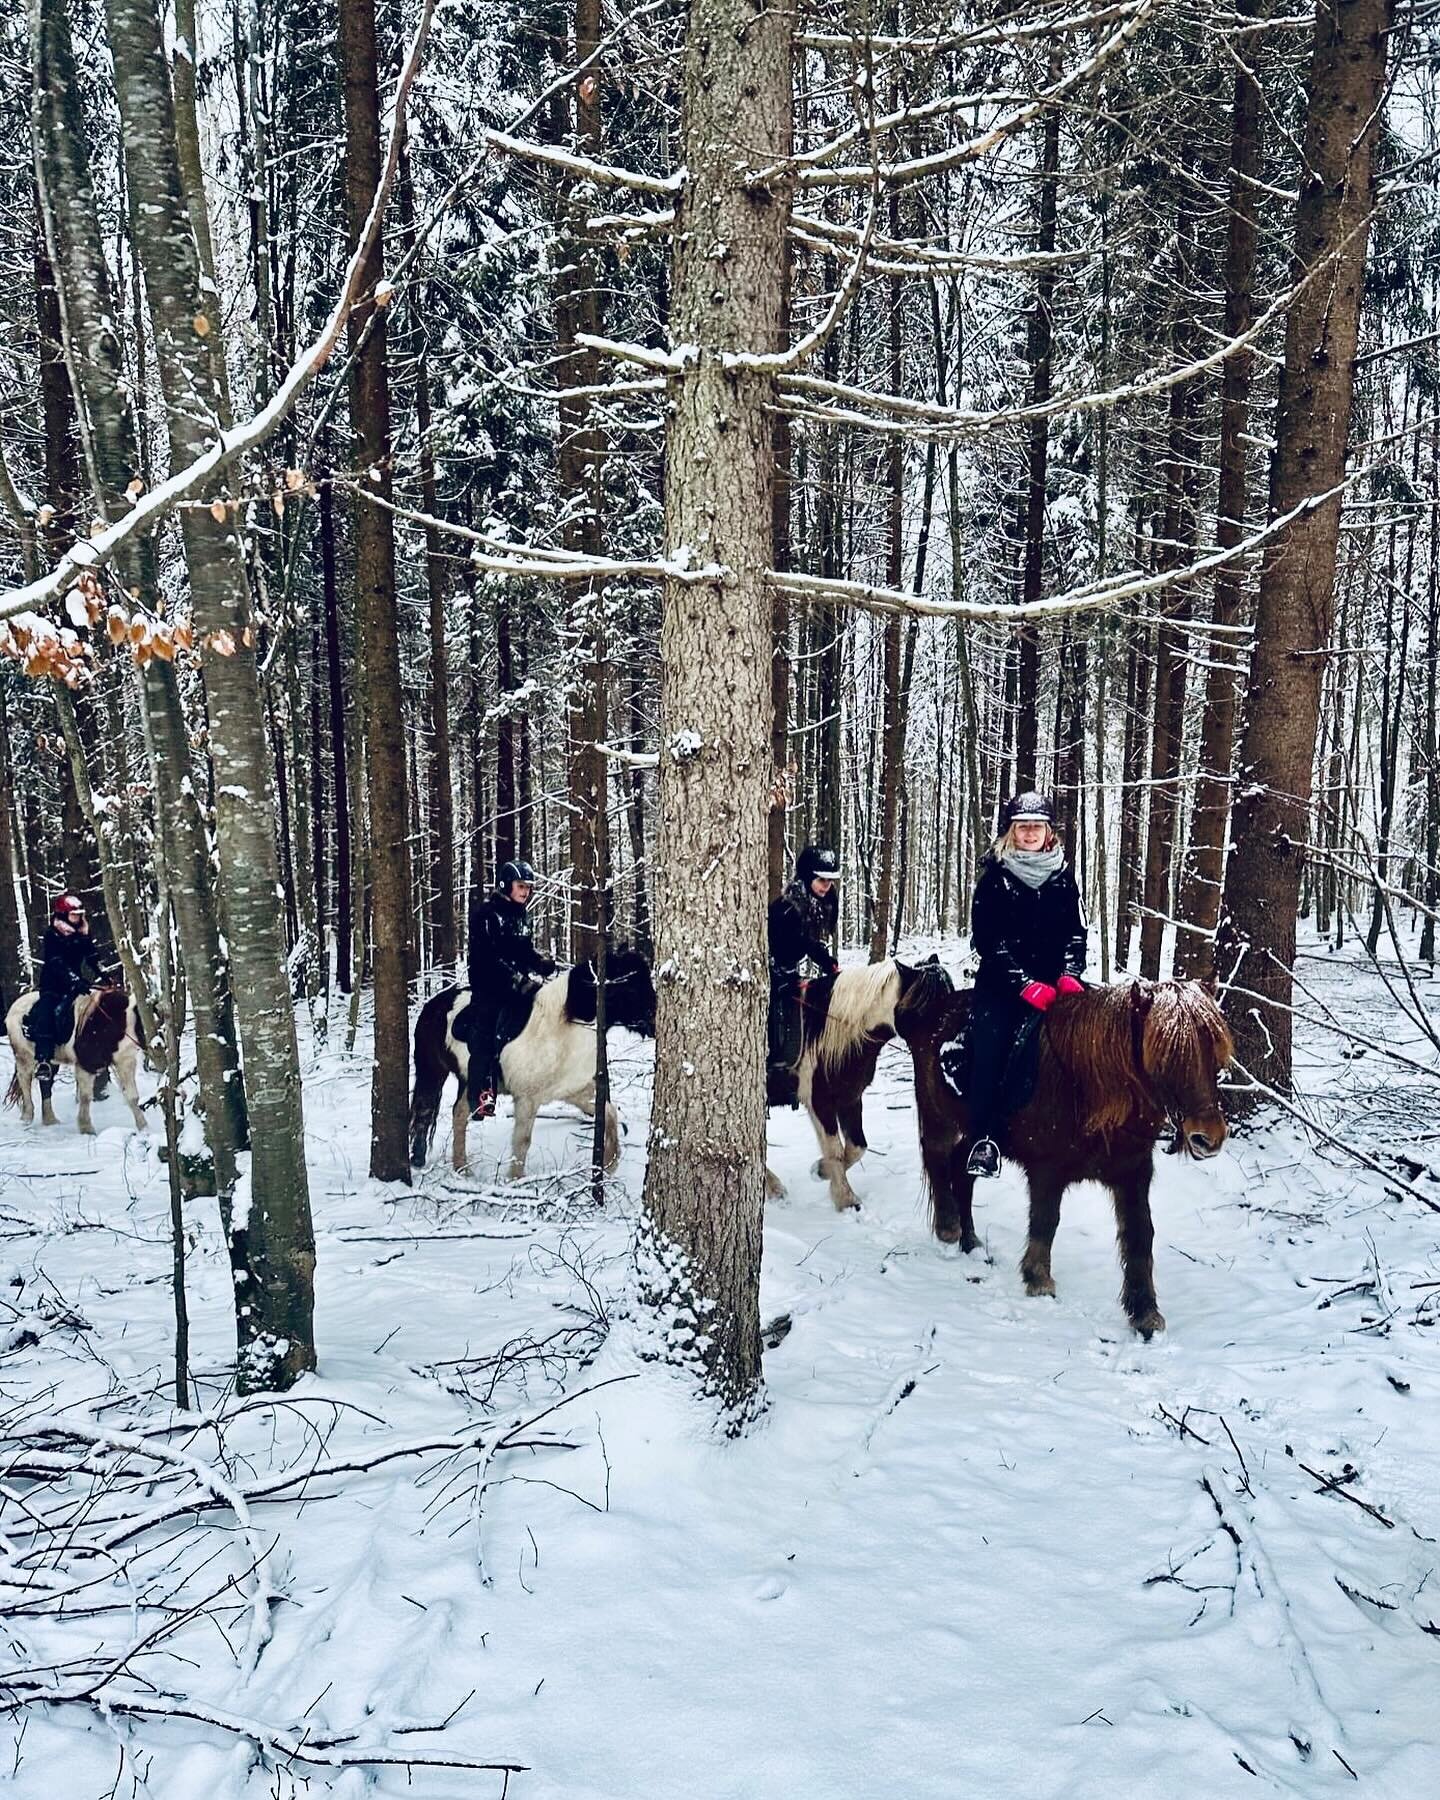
left=896, top=972, right=1231, bottom=1339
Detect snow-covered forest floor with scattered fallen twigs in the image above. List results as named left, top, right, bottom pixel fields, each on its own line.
left=0, top=943, right=1440, bottom=1800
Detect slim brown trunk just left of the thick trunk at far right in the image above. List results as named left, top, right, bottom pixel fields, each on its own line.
left=1175, top=10, right=1260, bottom=977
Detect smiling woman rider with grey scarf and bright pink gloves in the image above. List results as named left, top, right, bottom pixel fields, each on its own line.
left=941, top=792, right=1085, bottom=1175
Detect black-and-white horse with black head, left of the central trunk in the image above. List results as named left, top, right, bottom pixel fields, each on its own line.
left=410, top=950, right=655, bottom=1181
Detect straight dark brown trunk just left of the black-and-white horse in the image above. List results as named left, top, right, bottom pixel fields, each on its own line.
left=340, top=0, right=410, bottom=1181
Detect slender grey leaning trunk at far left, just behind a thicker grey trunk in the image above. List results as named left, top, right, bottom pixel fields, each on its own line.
left=32, top=0, right=248, bottom=1188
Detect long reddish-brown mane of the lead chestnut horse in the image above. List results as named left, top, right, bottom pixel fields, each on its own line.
left=1046, top=981, right=1233, bottom=1136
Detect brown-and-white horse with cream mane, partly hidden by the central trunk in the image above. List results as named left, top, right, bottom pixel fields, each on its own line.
left=765, top=958, right=936, bottom=1211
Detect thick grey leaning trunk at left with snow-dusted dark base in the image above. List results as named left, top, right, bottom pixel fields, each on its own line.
left=106, top=0, right=315, bottom=1391
